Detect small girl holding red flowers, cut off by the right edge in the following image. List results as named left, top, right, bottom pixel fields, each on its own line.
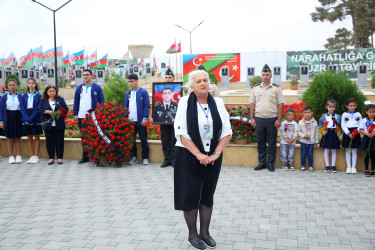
left=359, top=104, right=375, bottom=177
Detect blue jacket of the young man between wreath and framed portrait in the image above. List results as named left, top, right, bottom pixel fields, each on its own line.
left=124, top=87, right=150, bottom=124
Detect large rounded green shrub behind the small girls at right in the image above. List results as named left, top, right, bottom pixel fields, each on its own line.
left=302, top=71, right=366, bottom=119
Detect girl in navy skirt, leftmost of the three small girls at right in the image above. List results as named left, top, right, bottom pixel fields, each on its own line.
left=319, top=99, right=341, bottom=173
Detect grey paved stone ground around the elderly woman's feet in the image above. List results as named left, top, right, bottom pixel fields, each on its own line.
left=0, top=159, right=375, bottom=250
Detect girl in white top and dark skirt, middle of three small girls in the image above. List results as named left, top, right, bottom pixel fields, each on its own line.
left=341, top=98, right=362, bottom=174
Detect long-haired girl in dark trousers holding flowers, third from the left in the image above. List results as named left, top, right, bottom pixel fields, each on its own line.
left=38, top=85, right=69, bottom=165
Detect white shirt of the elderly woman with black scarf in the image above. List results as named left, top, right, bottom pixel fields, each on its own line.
left=174, top=96, right=232, bottom=152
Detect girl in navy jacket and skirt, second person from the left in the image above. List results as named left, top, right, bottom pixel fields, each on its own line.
left=21, top=77, right=43, bottom=164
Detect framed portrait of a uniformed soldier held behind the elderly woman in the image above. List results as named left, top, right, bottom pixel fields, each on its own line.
left=152, top=82, right=184, bottom=124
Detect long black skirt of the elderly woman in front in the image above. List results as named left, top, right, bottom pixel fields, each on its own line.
left=174, top=146, right=222, bottom=211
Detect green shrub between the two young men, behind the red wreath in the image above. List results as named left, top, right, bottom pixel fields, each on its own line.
left=103, top=72, right=130, bottom=104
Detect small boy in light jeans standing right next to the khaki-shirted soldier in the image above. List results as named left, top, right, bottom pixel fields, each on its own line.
left=280, top=108, right=297, bottom=171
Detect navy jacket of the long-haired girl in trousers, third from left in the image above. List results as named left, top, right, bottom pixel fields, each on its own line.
left=38, top=97, right=69, bottom=130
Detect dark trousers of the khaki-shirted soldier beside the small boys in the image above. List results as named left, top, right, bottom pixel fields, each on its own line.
left=255, top=117, right=277, bottom=166
